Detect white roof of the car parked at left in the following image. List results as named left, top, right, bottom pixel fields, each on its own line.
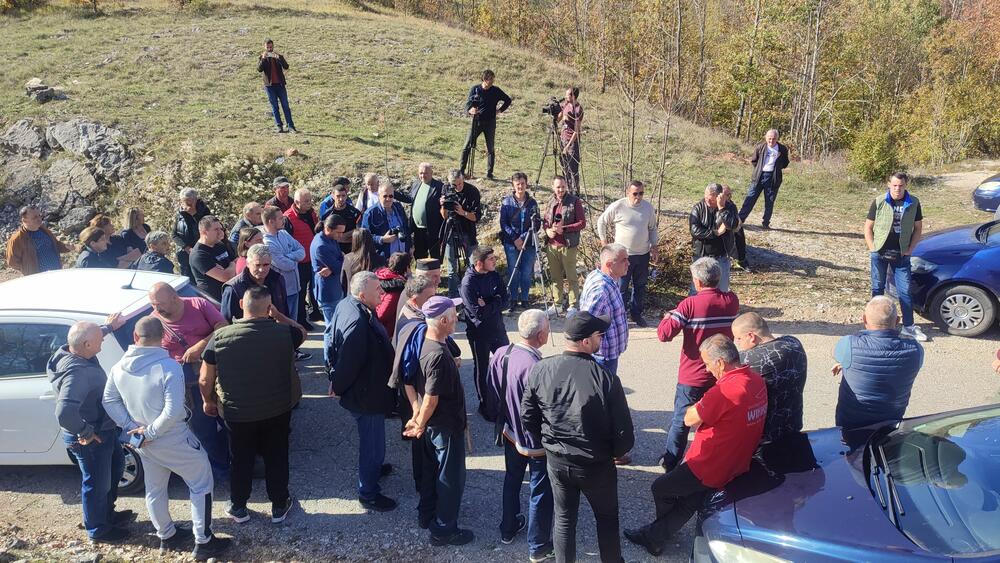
left=0, top=268, right=190, bottom=315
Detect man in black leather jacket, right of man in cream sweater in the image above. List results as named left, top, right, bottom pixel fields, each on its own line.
left=688, top=184, right=740, bottom=295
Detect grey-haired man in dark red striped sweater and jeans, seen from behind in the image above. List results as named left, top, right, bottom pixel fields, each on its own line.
left=656, top=257, right=740, bottom=471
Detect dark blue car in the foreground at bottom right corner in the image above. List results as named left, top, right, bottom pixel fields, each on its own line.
left=692, top=405, right=1000, bottom=563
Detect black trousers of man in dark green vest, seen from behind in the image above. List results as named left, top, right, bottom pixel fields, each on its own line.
left=226, top=411, right=292, bottom=508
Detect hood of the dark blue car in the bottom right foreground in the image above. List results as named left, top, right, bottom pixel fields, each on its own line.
left=726, top=429, right=926, bottom=560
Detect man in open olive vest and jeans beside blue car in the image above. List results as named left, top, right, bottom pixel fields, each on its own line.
left=865, top=172, right=927, bottom=342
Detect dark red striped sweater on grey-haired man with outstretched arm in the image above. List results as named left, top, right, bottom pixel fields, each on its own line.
left=656, top=287, right=740, bottom=387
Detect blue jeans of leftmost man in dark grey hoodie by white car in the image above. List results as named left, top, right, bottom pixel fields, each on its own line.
left=63, top=428, right=125, bottom=538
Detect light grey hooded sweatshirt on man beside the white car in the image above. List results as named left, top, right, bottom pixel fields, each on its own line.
left=103, top=346, right=187, bottom=441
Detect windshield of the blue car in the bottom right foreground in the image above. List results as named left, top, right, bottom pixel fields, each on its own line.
left=871, top=406, right=1000, bottom=556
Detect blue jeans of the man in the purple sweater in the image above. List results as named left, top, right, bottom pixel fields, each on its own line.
left=500, top=446, right=553, bottom=557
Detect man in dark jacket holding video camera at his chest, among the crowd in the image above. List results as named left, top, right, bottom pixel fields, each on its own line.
left=440, top=168, right=482, bottom=297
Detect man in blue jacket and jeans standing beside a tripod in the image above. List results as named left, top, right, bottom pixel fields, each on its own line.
left=500, top=172, right=544, bottom=312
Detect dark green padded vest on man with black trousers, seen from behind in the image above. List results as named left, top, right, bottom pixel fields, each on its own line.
left=214, top=319, right=302, bottom=422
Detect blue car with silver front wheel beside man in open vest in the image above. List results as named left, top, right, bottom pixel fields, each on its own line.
left=910, top=220, right=1000, bottom=336
